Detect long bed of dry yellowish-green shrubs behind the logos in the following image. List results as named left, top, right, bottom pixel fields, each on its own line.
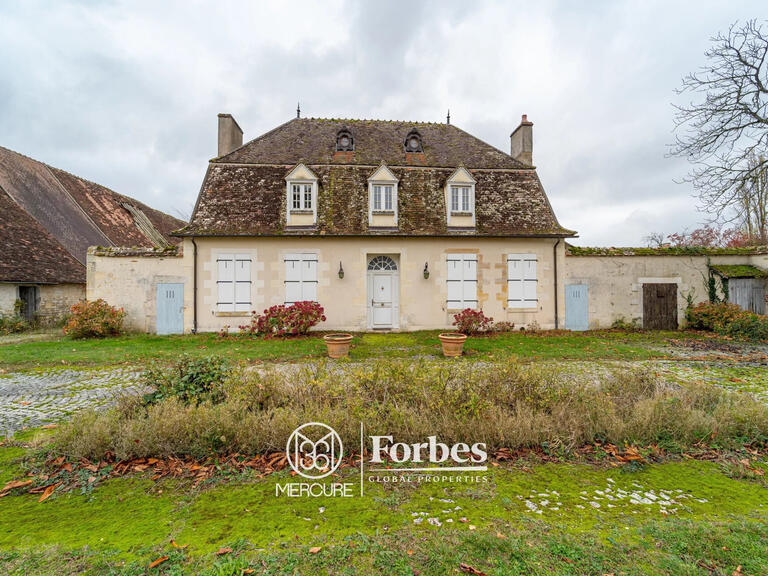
left=53, top=360, right=768, bottom=458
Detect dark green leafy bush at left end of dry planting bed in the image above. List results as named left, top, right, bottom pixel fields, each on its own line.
left=142, top=356, right=232, bottom=405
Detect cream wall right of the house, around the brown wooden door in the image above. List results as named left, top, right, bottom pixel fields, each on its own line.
left=563, top=248, right=768, bottom=329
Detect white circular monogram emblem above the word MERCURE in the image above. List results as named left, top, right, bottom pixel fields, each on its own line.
left=285, top=422, right=344, bottom=480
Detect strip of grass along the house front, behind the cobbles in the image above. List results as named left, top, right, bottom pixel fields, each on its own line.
left=0, top=330, right=704, bottom=369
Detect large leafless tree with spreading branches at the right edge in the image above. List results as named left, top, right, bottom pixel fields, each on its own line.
left=672, top=20, right=768, bottom=242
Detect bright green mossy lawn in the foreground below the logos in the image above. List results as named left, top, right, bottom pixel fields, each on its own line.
left=0, top=434, right=768, bottom=576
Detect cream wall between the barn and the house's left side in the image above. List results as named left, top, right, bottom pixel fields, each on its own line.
left=87, top=248, right=192, bottom=332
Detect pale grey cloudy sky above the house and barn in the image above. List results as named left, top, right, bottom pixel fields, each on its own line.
left=0, top=0, right=768, bottom=246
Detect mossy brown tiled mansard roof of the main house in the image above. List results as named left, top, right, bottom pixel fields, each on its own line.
left=177, top=118, right=574, bottom=237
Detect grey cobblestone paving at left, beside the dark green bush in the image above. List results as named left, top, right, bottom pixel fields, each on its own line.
left=0, top=369, right=141, bottom=438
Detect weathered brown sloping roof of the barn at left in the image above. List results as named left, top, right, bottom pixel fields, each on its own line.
left=0, top=147, right=184, bottom=282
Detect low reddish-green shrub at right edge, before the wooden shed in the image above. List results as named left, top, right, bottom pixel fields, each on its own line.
left=685, top=302, right=768, bottom=340
